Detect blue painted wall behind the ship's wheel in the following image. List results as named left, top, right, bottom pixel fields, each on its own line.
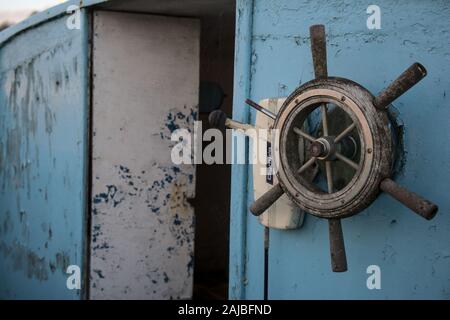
left=230, top=0, right=450, bottom=299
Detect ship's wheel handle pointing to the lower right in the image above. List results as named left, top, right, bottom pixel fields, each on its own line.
left=380, top=179, right=439, bottom=220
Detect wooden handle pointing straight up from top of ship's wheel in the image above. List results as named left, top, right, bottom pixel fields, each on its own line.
left=309, top=24, right=328, bottom=79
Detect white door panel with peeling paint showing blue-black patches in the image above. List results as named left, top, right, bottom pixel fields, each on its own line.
left=90, top=12, right=199, bottom=299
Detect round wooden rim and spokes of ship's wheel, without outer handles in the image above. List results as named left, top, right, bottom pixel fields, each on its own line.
left=274, top=78, right=393, bottom=218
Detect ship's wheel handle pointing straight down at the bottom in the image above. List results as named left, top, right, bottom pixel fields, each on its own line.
left=328, top=219, right=347, bottom=272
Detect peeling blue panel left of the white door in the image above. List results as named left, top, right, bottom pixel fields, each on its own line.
left=0, top=12, right=88, bottom=299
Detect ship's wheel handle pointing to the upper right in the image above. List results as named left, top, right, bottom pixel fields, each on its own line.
left=374, top=62, right=427, bottom=110
